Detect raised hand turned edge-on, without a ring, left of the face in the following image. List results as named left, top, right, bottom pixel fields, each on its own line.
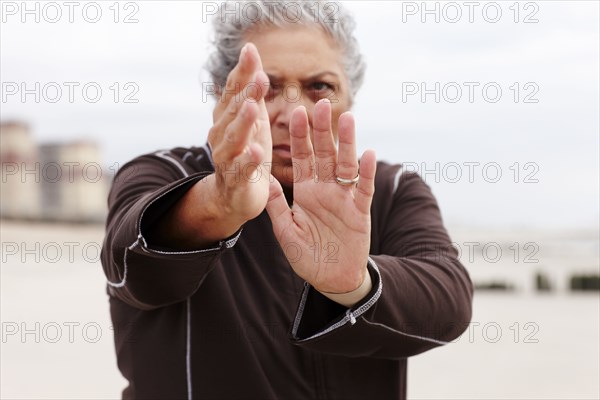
left=208, top=43, right=273, bottom=226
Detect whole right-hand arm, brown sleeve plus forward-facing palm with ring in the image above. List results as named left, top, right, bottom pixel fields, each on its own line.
left=267, top=101, right=472, bottom=358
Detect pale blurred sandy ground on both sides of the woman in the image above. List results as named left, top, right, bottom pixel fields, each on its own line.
left=0, top=221, right=600, bottom=399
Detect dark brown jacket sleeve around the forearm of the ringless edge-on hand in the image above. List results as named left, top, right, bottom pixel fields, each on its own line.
left=101, top=152, right=241, bottom=310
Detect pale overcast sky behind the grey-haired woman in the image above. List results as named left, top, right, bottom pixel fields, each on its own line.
left=0, top=1, right=599, bottom=229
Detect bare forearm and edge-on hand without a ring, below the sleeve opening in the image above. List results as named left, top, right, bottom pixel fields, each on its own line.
left=147, top=44, right=272, bottom=251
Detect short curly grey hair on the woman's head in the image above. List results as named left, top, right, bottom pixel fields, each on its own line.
left=205, top=0, right=366, bottom=100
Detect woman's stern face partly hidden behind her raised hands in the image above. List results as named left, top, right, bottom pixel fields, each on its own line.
left=246, top=24, right=351, bottom=188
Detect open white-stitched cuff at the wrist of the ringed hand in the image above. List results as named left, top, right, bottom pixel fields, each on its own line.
left=291, top=257, right=383, bottom=343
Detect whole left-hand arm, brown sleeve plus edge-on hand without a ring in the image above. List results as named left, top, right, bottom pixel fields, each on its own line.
left=102, top=44, right=272, bottom=309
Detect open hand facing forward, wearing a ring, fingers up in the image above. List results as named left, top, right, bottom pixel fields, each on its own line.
left=267, top=99, right=376, bottom=294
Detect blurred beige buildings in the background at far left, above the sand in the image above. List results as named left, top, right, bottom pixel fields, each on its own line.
left=0, top=122, right=111, bottom=222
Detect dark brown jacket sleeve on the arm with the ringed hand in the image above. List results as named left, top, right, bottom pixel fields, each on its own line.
left=291, top=164, right=473, bottom=359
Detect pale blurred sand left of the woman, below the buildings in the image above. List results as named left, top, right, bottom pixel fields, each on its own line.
left=0, top=222, right=126, bottom=399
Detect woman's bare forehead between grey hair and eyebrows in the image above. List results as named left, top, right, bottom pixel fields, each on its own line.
left=246, top=24, right=345, bottom=79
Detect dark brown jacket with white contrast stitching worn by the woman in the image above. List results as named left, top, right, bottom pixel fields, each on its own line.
left=102, top=147, right=472, bottom=400
